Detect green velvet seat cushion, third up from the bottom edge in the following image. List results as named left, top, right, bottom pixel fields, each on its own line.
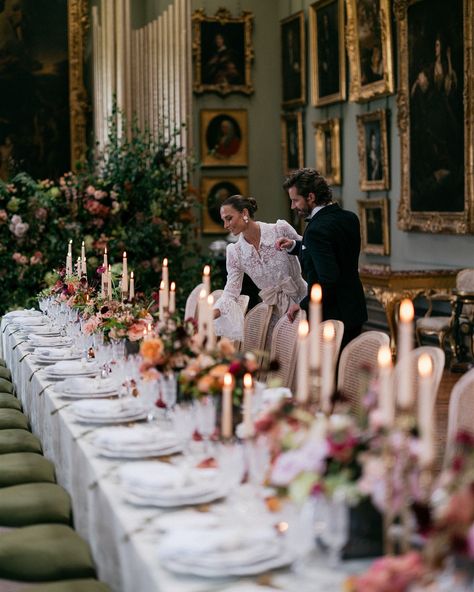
left=0, top=483, right=72, bottom=527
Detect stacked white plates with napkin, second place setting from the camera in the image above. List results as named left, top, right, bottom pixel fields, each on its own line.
left=120, top=461, right=228, bottom=508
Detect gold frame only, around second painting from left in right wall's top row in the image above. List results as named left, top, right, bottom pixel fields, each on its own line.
left=309, top=0, right=346, bottom=107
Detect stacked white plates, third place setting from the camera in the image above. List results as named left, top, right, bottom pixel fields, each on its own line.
left=94, top=425, right=182, bottom=458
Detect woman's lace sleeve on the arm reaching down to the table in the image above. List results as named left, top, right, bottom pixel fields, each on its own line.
left=214, top=245, right=244, bottom=341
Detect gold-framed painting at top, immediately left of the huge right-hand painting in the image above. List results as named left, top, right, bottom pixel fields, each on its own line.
left=346, top=0, right=394, bottom=102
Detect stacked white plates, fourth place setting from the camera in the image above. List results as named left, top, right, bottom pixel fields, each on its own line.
left=70, top=399, right=147, bottom=424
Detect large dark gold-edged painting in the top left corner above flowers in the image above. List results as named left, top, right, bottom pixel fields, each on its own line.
left=0, top=0, right=88, bottom=180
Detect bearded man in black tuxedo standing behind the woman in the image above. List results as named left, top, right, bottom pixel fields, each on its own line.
left=275, top=168, right=367, bottom=347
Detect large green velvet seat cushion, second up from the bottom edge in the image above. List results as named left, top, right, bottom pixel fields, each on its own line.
left=0, top=524, right=95, bottom=582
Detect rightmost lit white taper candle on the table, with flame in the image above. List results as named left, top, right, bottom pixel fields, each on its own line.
left=418, top=354, right=435, bottom=467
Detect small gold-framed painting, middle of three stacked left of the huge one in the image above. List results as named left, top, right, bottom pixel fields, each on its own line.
left=357, top=109, right=390, bottom=191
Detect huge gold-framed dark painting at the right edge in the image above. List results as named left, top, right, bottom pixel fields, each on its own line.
left=395, top=0, right=474, bottom=234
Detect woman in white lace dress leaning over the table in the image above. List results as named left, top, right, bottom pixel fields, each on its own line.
left=214, top=195, right=307, bottom=340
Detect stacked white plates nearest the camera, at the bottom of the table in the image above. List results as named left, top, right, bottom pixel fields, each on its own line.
left=159, top=522, right=295, bottom=578
